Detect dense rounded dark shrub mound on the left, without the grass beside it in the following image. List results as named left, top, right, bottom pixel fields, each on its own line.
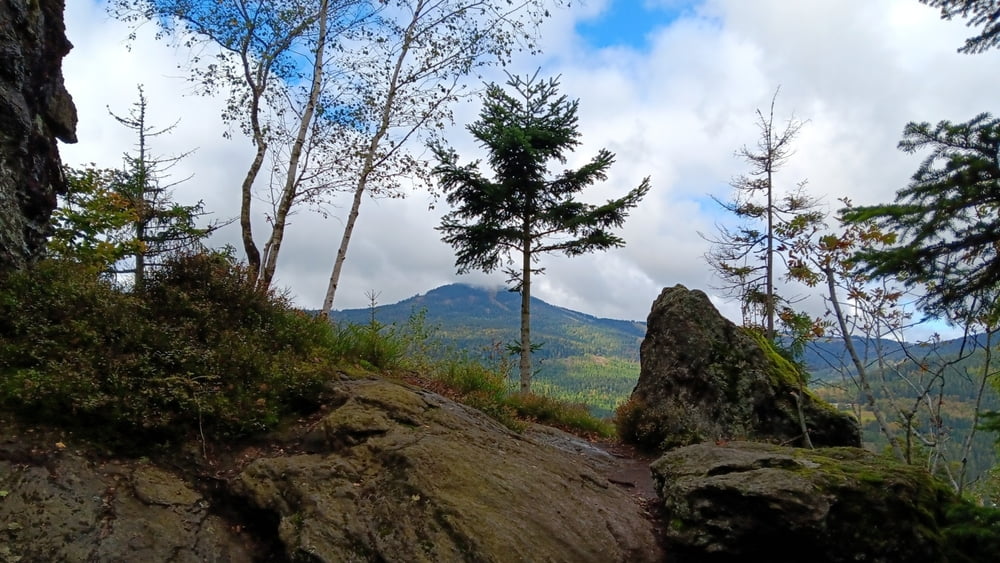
left=0, top=254, right=336, bottom=446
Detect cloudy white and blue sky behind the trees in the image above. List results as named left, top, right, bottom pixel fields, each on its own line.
left=60, top=0, right=1000, bottom=338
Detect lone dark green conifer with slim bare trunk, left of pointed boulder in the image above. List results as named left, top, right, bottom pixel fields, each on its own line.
left=433, top=72, right=650, bottom=393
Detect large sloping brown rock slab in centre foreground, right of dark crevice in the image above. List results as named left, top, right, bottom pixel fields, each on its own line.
left=233, top=381, right=662, bottom=563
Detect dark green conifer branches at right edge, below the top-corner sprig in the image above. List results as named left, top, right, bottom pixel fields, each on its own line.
left=843, top=113, right=1000, bottom=320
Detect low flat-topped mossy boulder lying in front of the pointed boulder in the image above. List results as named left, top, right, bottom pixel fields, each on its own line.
left=652, top=442, right=972, bottom=563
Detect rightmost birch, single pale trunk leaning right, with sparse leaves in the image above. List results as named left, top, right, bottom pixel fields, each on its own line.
left=321, top=0, right=549, bottom=316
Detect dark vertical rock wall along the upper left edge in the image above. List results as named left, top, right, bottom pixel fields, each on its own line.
left=0, top=0, right=76, bottom=269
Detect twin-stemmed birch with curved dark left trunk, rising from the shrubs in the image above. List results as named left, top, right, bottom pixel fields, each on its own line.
left=110, top=0, right=377, bottom=288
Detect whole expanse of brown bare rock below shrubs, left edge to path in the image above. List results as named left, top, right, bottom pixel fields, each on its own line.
left=0, top=380, right=664, bottom=563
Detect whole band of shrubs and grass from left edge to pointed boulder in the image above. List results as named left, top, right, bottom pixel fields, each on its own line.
left=0, top=252, right=611, bottom=449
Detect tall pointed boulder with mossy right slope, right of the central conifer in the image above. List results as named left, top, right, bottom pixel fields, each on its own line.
left=619, top=285, right=861, bottom=451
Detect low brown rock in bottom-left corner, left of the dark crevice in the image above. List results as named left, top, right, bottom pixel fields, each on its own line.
left=0, top=454, right=253, bottom=562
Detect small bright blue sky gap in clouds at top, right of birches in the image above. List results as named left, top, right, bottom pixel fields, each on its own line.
left=576, top=0, right=702, bottom=51
